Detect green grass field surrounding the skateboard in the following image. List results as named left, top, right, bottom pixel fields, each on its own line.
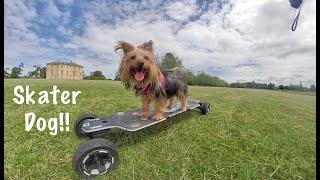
left=4, top=79, right=316, bottom=179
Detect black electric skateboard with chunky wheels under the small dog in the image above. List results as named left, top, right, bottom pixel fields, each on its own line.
left=72, top=100, right=210, bottom=179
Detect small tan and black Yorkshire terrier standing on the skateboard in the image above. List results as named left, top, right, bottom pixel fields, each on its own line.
left=115, top=40, right=188, bottom=120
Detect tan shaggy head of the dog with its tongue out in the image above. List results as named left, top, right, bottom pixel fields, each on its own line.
left=115, top=41, right=158, bottom=88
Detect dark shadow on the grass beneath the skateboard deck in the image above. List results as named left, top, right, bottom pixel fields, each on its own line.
left=104, top=111, right=199, bottom=148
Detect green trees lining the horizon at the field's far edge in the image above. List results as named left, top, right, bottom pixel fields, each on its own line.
left=4, top=53, right=316, bottom=92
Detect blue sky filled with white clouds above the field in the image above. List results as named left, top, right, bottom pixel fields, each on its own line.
left=4, top=0, right=316, bottom=86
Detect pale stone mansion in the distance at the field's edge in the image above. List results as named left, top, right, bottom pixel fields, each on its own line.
left=46, top=61, right=83, bottom=80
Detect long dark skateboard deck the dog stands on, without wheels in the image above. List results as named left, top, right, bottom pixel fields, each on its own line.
left=82, top=100, right=200, bottom=133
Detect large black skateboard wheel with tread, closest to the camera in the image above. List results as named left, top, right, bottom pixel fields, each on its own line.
left=72, top=138, right=118, bottom=179
